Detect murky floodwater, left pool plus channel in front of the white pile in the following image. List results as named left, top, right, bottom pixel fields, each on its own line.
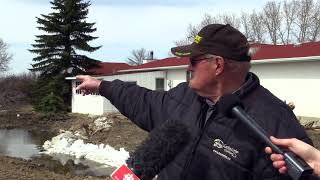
left=0, top=129, right=116, bottom=176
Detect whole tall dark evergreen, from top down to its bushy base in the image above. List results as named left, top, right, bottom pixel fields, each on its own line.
left=30, top=0, right=101, bottom=112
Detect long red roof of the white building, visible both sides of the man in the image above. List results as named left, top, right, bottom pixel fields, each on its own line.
left=93, top=42, right=320, bottom=75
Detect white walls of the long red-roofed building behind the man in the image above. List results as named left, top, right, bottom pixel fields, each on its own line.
left=72, top=61, right=320, bottom=117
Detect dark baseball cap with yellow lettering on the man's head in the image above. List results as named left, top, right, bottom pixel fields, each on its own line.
left=171, top=24, right=251, bottom=61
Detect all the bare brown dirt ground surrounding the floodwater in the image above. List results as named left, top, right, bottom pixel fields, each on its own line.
left=0, top=107, right=320, bottom=180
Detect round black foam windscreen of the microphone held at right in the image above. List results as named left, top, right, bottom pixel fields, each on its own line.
left=218, top=94, right=243, bottom=117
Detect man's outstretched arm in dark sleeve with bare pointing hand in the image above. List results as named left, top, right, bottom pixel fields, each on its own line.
left=76, top=75, right=172, bottom=131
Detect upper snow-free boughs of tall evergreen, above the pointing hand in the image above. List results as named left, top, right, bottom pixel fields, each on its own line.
left=30, top=0, right=101, bottom=76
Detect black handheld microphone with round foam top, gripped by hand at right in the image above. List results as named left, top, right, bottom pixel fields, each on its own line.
left=218, top=94, right=313, bottom=180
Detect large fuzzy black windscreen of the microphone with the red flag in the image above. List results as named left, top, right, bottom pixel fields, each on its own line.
left=126, top=120, right=191, bottom=180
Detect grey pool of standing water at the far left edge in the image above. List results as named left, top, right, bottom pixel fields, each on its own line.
left=0, top=129, right=40, bottom=159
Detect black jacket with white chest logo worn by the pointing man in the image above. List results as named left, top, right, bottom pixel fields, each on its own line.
left=99, top=73, right=312, bottom=180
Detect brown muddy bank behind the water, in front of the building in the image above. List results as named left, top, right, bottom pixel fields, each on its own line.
left=0, top=111, right=147, bottom=151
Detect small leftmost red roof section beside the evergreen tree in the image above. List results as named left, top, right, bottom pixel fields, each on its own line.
left=91, top=62, right=131, bottom=76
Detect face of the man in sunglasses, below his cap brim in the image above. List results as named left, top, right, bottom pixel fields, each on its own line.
left=188, top=55, right=217, bottom=96
